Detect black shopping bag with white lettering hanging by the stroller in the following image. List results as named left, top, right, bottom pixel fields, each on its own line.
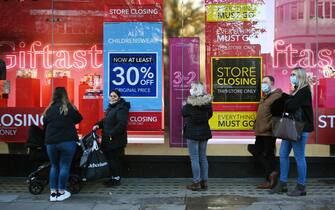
left=84, top=141, right=109, bottom=181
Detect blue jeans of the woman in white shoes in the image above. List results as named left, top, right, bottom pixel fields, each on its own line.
left=47, top=141, right=77, bottom=190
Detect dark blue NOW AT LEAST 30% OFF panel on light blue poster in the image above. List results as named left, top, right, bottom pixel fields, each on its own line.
left=109, top=52, right=158, bottom=98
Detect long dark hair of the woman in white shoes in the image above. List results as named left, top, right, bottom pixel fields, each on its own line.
left=43, top=87, right=71, bottom=115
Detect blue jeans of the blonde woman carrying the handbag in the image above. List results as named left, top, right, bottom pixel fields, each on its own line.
left=280, top=132, right=308, bottom=185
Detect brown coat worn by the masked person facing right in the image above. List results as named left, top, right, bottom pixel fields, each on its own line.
left=254, top=89, right=282, bottom=136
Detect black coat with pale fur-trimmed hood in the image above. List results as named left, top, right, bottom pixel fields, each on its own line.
left=182, top=95, right=213, bottom=141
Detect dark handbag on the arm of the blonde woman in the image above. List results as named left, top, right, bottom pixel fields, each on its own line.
left=272, top=108, right=305, bottom=141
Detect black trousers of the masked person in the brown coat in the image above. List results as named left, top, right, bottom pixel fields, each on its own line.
left=255, top=136, right=276, bottom=178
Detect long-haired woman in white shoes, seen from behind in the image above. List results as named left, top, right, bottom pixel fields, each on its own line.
left=43, top=87, right=83, bottom=201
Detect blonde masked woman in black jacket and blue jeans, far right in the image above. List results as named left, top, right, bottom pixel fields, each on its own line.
left=270, top=67, right=314, bottom=196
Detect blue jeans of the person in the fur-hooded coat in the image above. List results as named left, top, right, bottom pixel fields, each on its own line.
left=187, top=139, right=208, bottom=182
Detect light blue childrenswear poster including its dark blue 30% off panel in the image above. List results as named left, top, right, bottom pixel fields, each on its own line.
left=104, top=22, right=163, bottom=112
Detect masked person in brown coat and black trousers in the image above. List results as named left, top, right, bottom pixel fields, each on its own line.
left=253, top=76, right=283, bottom=189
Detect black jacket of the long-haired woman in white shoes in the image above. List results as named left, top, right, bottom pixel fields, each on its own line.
left=43, top=102, right=83, bottom=144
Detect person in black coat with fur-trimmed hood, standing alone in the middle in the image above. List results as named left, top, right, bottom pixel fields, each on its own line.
left=182, top=83, right=213, bottom=191
